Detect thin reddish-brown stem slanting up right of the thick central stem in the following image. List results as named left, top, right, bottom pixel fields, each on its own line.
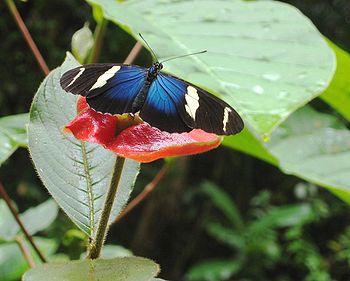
left=112, top=164, right=169, bottom=224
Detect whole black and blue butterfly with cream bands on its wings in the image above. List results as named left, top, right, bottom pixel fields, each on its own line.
left=60, top=56, right=244, bottom=135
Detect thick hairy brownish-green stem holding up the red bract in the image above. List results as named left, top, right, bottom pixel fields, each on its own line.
left=87, top=156, right=125, bottom=259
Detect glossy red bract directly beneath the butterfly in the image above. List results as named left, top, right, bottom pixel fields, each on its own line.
left=66, top=98, right=222, bottom=163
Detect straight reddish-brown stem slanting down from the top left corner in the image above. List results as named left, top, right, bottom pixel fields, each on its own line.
left=6, top=0, right=50, bottom=75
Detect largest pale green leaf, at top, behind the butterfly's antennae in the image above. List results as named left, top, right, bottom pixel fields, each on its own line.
left=88, top=0, right=335, bottom=135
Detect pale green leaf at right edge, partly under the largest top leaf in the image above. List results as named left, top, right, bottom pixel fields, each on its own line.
left=225, top=107, right=350, bottom=204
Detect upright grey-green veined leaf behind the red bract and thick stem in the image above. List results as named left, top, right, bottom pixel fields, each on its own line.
left=28, top=54, right=140, bottom=236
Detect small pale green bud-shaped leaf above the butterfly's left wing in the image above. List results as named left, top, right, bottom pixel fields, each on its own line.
left=71, top=23, right=94, bottom=63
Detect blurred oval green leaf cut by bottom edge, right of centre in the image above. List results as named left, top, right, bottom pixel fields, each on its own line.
left=186, top=259, right=242, bottom=281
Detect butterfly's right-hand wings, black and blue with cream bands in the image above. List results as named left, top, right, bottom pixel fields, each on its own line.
left=140, top=73, right=244, bottom=135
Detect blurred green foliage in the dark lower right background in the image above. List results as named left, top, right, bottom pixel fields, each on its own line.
left=187, top=182, right=342, bottom=281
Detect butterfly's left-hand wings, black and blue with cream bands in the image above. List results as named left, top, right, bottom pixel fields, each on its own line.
left=61, top=63, right=147, bottom=114
